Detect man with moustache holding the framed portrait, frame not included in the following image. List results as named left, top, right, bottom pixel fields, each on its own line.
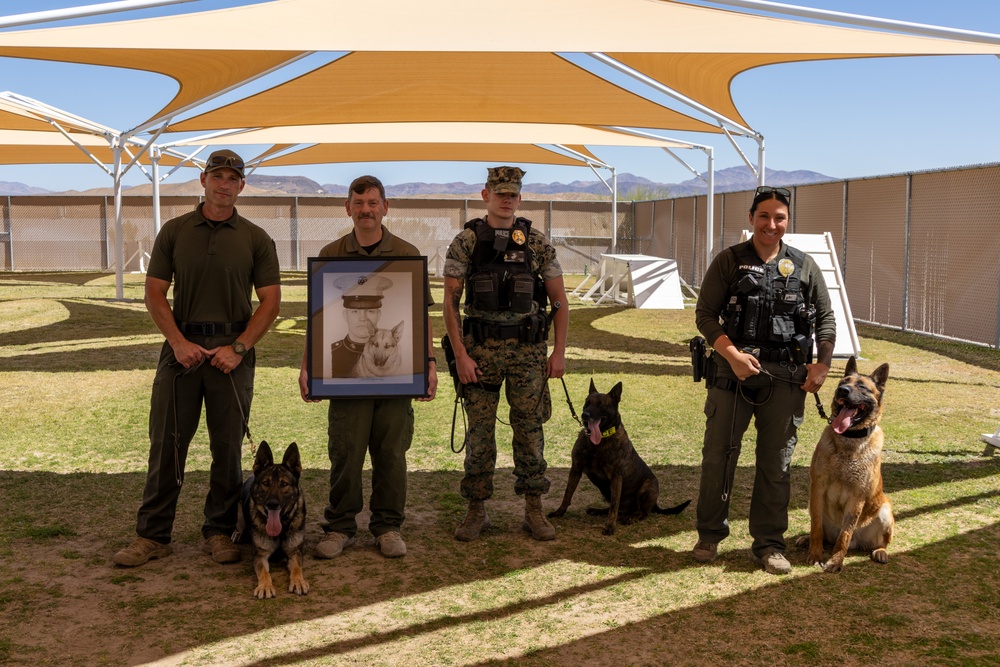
left=299, top=176, right=437, bottom=558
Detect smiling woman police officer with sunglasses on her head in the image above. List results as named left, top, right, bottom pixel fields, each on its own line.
left=692, top=186, right=836, bottom=574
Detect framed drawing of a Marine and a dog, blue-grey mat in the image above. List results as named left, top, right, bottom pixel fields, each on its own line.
left=306, top=257, right=428, bottom=398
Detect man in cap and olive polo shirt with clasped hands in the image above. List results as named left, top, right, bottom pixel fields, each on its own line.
left=112, top=150, right=281, bottom=567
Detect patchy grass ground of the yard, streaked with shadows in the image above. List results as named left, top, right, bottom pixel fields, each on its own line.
left=0, top=273, right=1000, bottom=667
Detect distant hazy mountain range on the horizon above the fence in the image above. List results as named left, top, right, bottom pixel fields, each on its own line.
left=0, top=167, right=837, bottom=200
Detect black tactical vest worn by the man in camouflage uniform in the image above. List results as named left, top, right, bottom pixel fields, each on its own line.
left=465, top=218, right=544, bottom=313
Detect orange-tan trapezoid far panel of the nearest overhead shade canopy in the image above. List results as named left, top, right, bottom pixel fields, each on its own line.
left=168, top=52, right=719, bottom=132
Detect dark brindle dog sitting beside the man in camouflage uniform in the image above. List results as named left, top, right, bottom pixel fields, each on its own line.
left=549, top=379, right=691, bottom=535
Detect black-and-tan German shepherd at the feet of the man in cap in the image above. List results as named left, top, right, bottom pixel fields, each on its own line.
left=233, top=441, right=309, bottom=600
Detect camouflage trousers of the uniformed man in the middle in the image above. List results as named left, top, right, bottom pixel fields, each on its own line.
left=461, top=336, right=552, bottom=500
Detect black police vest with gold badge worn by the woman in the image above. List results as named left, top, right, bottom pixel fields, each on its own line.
left=723, top=240, right=816, bottom=348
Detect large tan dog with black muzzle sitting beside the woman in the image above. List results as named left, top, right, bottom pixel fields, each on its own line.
left=796, top=357, right=895, bottom=572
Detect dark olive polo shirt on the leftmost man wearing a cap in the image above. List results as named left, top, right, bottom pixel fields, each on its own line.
left=146, top=204, right=281, bottom=322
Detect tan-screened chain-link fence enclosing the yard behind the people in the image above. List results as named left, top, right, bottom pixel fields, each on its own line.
left=0, top=165, right=1000, bottom=347
